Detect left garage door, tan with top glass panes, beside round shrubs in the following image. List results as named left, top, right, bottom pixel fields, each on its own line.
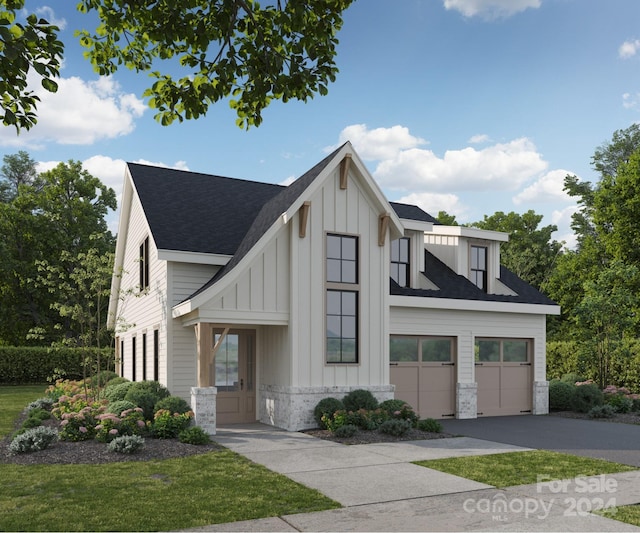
left=390, top=336, right=456, bottom=418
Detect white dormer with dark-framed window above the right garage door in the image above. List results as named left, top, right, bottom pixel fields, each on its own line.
left=424, top=225, right=514, bottom=295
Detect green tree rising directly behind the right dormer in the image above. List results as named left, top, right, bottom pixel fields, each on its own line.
left=470, top=210, right=563, bottom=290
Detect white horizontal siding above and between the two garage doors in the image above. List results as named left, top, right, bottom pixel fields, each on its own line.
left=390, top=306, right=546, bottom=383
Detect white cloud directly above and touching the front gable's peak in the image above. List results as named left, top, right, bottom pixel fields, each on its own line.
left=325, top=124, right=427, bottom=161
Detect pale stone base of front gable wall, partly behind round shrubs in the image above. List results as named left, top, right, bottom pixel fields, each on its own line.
left=258, top=385, right=395, bottom=431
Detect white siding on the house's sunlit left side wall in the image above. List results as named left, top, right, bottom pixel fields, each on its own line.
left=116, top=195, right=168, bottom=383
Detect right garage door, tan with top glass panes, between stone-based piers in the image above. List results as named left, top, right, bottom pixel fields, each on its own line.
left=475, top=339, right=533, bottom=416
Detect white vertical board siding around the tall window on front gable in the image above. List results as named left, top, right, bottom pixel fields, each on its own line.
left=289, top=169, right=389, bottom=387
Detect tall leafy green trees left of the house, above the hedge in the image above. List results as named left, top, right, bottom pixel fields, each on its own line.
left=0, top=152, right=116, bottom=345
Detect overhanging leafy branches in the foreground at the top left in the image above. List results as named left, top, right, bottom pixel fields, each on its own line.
left=0, top=0, right=353, bottom=131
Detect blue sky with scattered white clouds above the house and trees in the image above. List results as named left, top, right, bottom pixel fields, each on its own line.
left=0, top=0, right=640, bottom=244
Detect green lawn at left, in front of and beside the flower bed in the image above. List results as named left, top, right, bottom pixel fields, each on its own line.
left=0, top=385, right=340, bottom=531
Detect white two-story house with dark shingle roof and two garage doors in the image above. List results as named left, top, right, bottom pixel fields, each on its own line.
left=109, top=143, right=559, bottom=432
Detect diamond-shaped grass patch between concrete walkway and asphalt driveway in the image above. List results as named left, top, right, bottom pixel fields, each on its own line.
left=415, top=450, right=637, bottom=487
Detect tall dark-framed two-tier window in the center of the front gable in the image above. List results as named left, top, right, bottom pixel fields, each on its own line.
left=326, top=235, right=360, bottom=363
